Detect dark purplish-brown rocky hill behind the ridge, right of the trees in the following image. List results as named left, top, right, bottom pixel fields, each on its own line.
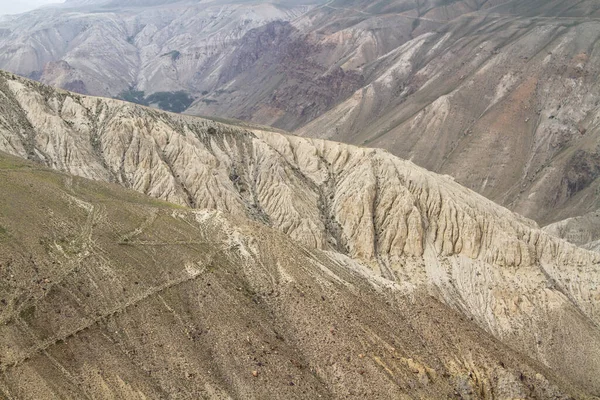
left=199, top=21, right=363, bottom=128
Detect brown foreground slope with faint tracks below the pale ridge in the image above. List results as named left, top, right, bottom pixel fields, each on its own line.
left=0, top=153, right=583, bottom=400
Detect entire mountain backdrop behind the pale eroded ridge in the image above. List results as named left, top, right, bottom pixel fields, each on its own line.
left=0, top=0, right=600, bottom=247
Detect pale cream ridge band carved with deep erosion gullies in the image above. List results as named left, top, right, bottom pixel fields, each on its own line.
left=0, top=69, right=600, bottom=394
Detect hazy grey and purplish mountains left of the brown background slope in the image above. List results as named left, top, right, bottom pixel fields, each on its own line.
left=0, top=0, right=507, bottom=129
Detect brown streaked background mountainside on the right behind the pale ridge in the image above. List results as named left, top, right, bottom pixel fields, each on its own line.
left=298, top=0, right=600, bottom=224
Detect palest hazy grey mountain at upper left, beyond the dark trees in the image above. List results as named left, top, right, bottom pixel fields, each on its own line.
left=0, top=0, right=312, bottom=97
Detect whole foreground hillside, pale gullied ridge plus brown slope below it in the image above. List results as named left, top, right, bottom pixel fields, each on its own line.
left=0, top=73, right=600, bottom=399
